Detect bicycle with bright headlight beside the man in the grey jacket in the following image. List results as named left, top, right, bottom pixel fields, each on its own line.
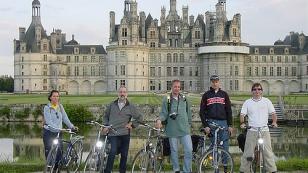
left=83, top=121, right=117, bottom=173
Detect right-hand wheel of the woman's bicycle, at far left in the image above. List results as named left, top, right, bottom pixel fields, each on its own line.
left=66, top=140, right=83, bottom=172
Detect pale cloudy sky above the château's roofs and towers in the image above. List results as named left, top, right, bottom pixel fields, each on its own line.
left=0, top=0, right=308, bottom=76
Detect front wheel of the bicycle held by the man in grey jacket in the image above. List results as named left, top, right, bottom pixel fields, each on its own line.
left=83, top=151, right=102, bottom=173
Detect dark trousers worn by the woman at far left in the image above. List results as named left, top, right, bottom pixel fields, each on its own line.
left=43, top=129, right=63, bottom=167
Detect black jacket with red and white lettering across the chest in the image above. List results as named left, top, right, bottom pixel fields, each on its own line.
left=199, top=87, right=232, bottom=127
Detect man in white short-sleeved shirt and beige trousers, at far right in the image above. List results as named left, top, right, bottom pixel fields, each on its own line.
left=240, top=83, right=277, bottom=173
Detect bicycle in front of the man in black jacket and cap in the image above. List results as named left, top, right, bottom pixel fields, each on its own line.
left=198, top=122, right=234, bottom=173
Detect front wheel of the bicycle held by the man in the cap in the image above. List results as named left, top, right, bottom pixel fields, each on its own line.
left=198, top=148, right=234, bottom=173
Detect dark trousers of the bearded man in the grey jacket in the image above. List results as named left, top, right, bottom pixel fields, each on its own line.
left=105, top=135, right=130, bottom=173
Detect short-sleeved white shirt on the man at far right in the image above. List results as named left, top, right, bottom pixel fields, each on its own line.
left=241, top=97, right=275, bottom=130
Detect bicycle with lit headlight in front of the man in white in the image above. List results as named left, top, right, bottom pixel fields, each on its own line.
left=246, top=125, right=273, bottom=173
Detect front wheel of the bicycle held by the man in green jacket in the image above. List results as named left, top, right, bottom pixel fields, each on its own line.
left=132, top=149, right=155, bottom=173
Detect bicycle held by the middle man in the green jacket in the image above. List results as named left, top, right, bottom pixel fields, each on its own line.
left=132, top=122, right=164, bottom=173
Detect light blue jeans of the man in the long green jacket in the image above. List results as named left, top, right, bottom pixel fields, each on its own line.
left=169, top=135, right=192, bottom=173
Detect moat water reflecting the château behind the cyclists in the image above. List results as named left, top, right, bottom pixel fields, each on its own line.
left=0, top=123, right=308, bottom=162
